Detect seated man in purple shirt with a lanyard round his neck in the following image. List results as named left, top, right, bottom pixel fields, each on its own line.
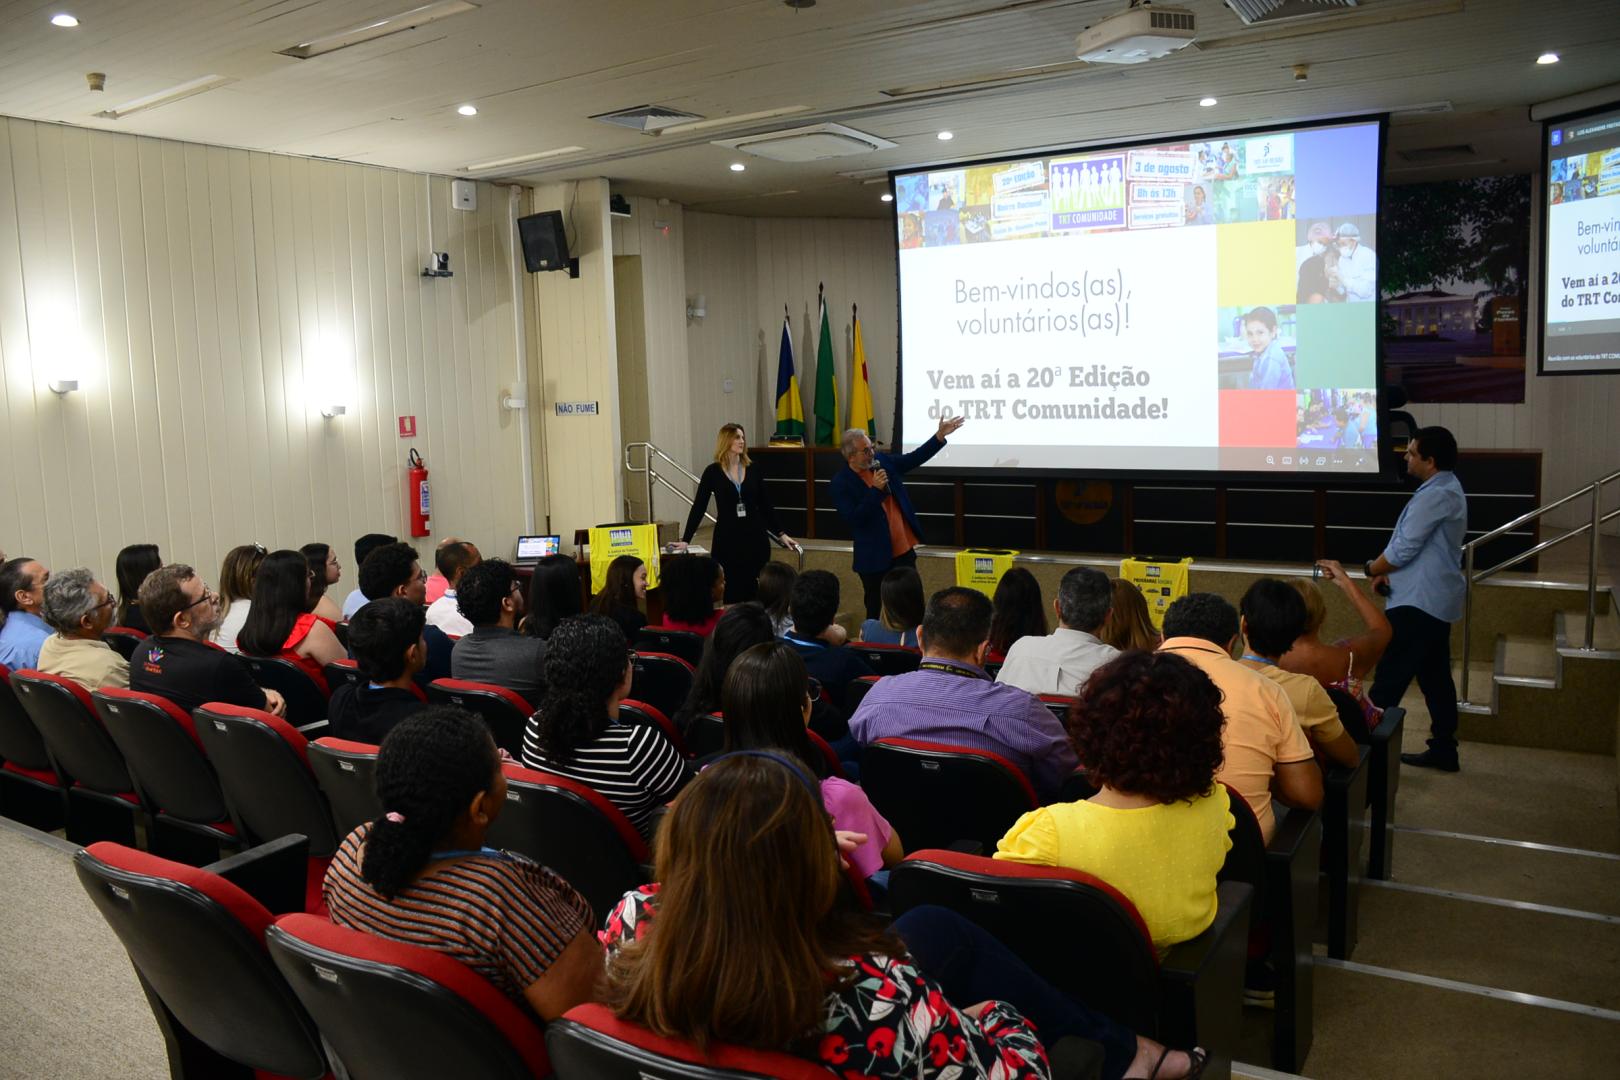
left=849, top=586, right=1079, bottom=800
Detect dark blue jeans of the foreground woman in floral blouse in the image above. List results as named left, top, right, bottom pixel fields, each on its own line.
left=894, top=905, right=1136, bottom=1080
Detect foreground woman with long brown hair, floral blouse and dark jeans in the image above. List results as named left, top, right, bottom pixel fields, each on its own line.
left=601, top=751, right=1202, bottom=1080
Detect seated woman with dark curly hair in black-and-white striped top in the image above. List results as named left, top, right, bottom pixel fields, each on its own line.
left=523, top=615, right=692, bottom=836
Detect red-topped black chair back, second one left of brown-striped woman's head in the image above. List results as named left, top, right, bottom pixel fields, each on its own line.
left=193, top=703, right=342, bottom=858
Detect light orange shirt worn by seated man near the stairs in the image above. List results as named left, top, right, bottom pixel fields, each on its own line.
left=1158, top=638, right=1315, bottom=844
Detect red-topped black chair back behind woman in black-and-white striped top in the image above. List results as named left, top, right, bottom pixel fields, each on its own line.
left=488, top=764, right=651, bottom=920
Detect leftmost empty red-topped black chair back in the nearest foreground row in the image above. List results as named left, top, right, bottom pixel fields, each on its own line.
left=73, top=842, right=327, bottom=1080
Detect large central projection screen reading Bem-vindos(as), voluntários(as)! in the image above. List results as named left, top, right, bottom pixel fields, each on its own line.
left=893, top=120, right=1382, bottom=478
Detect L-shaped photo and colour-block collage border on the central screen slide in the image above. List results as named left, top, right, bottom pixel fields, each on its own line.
left=894, top=125, right=1379, bottom=468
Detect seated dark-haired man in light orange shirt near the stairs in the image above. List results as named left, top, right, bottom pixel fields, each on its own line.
left=1158, top=593, right=1322, bottom=842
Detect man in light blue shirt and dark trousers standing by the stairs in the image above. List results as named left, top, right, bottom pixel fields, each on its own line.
left=1364, top=427, right=1468, bottom=772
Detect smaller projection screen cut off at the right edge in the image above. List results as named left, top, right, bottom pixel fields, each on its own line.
left=1541, top=105, right=1620, bottom=376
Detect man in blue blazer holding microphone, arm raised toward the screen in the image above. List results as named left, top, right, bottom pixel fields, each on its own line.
left=833, top=416, right=966, bottom=619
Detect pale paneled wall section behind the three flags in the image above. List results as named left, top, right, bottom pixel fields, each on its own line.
left=685, top=214, right=897, bottom=455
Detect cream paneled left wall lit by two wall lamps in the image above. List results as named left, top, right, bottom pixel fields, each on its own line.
left=0, top=117, right=523, bottom=589
